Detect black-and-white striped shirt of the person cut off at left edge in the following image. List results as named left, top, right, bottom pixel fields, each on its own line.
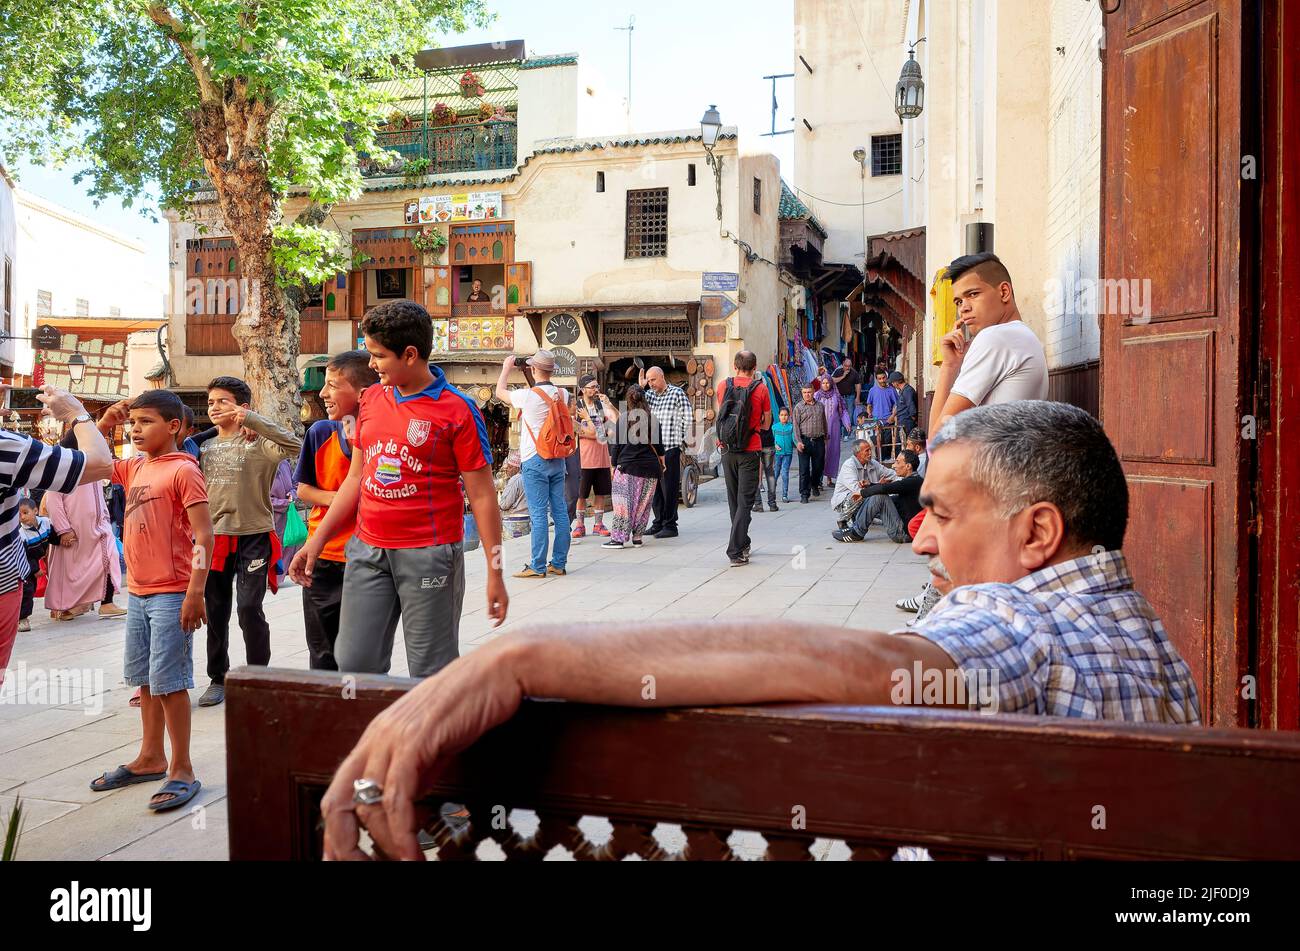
left=0, top=430, right=86, bottom=595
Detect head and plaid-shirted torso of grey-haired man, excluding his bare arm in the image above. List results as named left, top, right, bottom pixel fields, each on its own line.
left=896, top=400, right=1200, bottom=724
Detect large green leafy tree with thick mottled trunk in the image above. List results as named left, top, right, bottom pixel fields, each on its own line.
left=0, top=0, right=488, bottom=425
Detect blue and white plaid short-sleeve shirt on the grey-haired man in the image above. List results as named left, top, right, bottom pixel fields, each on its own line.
left=896, top=551, right=1201, bottom=724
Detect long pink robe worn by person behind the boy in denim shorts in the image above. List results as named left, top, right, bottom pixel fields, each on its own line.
left=44, top=482, right=125, bottom=621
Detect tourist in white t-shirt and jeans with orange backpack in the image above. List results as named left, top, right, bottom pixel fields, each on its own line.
left=497, top=349, right=576, bottom=578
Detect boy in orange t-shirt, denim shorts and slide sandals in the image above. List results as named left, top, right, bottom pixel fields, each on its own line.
left=90, top=390, right=212, bottom=812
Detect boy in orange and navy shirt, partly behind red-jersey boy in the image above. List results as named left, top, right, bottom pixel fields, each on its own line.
left=294, top=349, right=380, bottom=670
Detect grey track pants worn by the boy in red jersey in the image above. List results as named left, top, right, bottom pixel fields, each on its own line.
left=334, top=535, right=465, bottom=677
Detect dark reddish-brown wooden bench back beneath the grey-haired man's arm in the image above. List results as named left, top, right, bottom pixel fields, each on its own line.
left=226, top=668, right=1300, bottom=861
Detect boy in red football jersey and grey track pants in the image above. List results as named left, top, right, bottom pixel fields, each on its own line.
left=289, top=300, right=508, bottom=677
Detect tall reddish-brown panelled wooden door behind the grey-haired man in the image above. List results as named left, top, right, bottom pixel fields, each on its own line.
left=1099, top=0, right=1251, bottom=726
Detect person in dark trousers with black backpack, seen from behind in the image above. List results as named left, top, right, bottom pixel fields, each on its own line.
left=716, top=349, right=772, bottom=568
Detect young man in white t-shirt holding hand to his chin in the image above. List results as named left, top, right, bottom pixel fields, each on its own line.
left=930, top=252, right=1048, bottom=433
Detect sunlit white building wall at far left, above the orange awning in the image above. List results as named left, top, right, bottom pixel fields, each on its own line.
left=13, top=188, right=166, bottom=373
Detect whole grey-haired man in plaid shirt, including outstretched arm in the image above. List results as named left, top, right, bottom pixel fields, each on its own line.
left=321, top=400, right=1200, bottom=859
